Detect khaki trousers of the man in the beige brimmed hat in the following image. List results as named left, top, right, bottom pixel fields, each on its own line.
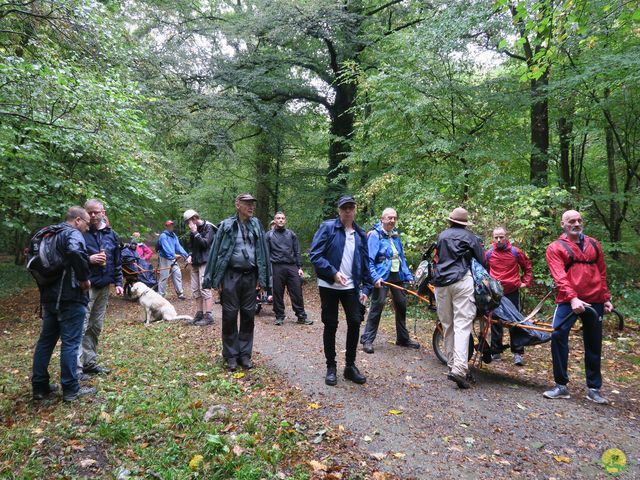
left=435, top=272, right=476, bottom=376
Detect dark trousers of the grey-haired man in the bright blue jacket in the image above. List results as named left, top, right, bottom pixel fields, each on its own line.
left=360, top=273, right=410, bottom=344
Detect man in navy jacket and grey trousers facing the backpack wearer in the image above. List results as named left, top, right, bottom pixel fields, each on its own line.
left=79, top=199, right=123, bottom=375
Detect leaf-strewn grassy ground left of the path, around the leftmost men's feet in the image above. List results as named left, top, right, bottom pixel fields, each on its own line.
left=0, top=319, right=316, bottom=480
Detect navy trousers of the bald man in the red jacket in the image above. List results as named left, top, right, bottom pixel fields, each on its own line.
left=551, top=303, right=604, bottom=388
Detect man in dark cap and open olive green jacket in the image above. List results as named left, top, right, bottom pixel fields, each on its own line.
left=202, top=193, right=271, bottom=370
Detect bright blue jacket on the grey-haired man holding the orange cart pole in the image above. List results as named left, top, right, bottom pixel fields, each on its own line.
left=367, top=222, right=413, bottom=283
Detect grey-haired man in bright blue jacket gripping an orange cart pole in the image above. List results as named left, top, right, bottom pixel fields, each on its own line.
left=360, top=208, right=420, bottom=353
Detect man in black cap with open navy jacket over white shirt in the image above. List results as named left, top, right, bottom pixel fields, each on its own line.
left=310, top=195, right=373, bottom=386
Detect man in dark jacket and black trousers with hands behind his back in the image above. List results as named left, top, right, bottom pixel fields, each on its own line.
left=265, top=212, right=313, bottom=325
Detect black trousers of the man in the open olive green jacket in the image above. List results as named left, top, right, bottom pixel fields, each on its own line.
left=220, top=268, right=258, bottom=358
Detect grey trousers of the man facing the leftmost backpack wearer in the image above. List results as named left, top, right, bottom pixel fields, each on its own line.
left=78, top=285, right=110, bottom=370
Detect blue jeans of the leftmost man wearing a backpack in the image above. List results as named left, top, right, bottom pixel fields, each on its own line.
left=31, top=303, right=87, bottom=394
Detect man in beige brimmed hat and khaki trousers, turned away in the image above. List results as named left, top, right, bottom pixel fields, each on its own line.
left=431, top=207, right=486, bottom=388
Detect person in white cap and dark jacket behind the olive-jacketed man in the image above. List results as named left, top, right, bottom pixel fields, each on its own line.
left=182, top=209, right=217, bottom=326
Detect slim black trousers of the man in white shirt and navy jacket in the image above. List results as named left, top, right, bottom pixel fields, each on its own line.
left=319, top=287, right=364, bottom=367
